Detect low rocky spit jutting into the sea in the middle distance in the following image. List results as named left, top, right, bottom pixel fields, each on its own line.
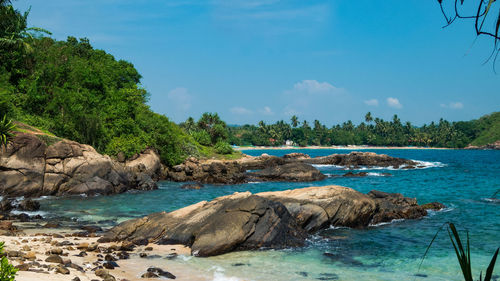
left=165, top=152, right=419, bottom=184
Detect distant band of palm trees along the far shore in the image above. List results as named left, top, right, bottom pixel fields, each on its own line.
left=229, top=112, right=500, bottom=148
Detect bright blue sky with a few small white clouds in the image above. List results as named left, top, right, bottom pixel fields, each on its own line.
left=14, top=0, right=500, bottom=125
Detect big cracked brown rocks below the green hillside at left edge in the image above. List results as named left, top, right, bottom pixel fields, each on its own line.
left=0, top=133, right=159, bottom=197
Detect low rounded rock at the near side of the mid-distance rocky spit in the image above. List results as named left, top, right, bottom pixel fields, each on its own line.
left=248, top=163, right=326, bottom=182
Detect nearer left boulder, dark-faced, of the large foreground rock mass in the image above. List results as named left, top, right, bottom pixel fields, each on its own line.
left=100, top=192, right=306, bottom=256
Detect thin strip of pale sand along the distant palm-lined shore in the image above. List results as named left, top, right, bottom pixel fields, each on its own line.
left=234, top=145, right=457, bottom=151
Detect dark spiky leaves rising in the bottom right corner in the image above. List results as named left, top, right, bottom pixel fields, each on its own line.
left=419, top=223, right=500, bottom=281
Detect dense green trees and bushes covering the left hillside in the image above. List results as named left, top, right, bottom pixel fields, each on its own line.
left=0, top=2, right=212, bottom=165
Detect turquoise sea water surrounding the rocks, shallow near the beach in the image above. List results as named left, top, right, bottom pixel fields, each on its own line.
left=37, top=149, right=500, bottom=280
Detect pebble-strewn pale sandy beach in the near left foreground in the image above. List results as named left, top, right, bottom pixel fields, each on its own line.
left=0, top=223, right=212, bottom=281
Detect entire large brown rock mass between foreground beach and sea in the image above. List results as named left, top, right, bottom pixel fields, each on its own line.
left=101, top=186, right=442, bottom=256
